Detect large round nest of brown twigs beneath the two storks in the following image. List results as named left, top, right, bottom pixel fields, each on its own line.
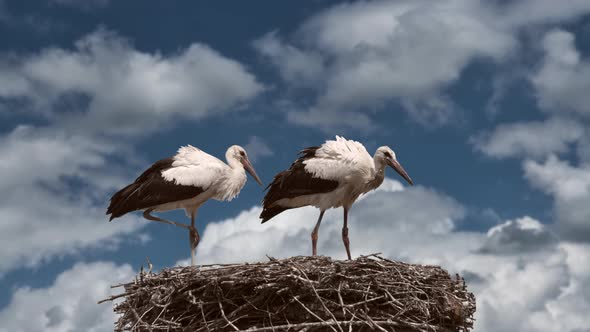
left=101, top=255, right=475, bottom=332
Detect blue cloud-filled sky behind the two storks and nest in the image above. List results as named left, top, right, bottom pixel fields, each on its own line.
left=0, top=0, right=590, bottom=332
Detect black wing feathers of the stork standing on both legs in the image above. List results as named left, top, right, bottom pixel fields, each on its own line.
left=260, top=146, right=338, bottom=223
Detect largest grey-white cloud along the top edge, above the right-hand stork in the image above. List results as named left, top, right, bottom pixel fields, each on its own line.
left=254, top=0, right=590, bottom=129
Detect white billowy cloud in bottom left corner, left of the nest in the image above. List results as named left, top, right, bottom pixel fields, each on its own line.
left=0, top=262, right=134, bottom=332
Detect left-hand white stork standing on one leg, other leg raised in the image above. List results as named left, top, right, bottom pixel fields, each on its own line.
left=107, top=145, right=262, bottom=265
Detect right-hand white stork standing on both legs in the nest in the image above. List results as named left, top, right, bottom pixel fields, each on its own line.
left=260, top=136, right=414, bottom=259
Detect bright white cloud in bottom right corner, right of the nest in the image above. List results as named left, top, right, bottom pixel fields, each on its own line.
left=476, top=243, right=590, bottom=332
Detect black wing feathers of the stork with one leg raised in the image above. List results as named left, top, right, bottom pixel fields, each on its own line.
left=106, top=158, right=204, bottom=220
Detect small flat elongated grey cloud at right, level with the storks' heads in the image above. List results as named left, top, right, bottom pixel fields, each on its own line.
left=470, top=117, right=585, bottom=159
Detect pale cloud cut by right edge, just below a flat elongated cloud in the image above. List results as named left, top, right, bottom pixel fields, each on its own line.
left=523, top=156, right=590, bottom=242
